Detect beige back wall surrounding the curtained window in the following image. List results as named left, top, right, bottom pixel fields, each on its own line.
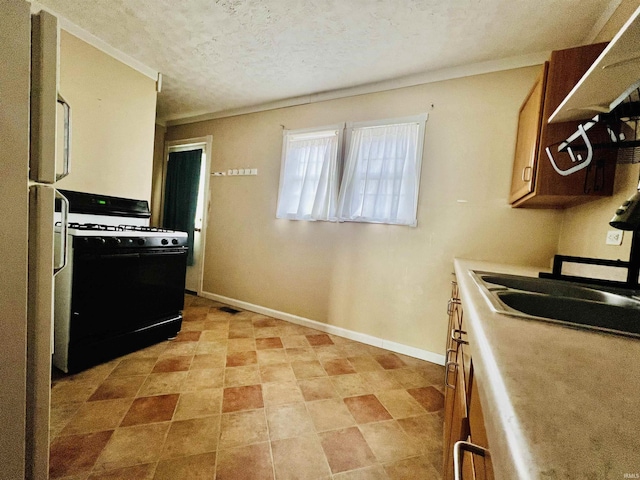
left=166, top=67, right=563, bottom=354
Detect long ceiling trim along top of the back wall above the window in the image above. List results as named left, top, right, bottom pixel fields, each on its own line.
left=166, top=50, right=552, bottom=126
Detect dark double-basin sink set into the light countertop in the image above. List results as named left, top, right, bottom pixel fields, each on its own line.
left=470, top=270, right=640, bottom=337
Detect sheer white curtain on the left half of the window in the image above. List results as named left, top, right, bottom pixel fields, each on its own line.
left=276, top=131, right=339, bottom=220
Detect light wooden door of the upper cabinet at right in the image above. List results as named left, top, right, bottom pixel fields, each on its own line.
left=509, top=62, right=549, bottom=203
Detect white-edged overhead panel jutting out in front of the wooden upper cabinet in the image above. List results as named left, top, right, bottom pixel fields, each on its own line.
left=549, top=7, right=640, bottom=123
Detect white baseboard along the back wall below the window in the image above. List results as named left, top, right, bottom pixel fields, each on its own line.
left=200, top=292, right=444, bottom=365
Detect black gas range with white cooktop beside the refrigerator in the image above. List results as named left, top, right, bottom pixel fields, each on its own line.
left=53, top=191, right=188, bottom=372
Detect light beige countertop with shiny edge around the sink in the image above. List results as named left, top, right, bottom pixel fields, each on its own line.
left=455, top=259, right=640, bottom=480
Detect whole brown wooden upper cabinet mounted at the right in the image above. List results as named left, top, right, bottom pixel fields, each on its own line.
left=509, top=43, right=616, bottom=208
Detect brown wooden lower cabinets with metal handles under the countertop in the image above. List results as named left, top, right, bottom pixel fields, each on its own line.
left=444, top=281, right=494, bottom=480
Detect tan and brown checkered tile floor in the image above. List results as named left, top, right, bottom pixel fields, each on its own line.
left=50, top=296, right=443, bottom=480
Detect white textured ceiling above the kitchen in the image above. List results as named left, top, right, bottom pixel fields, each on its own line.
left=39, top=0, right=615, bottom=119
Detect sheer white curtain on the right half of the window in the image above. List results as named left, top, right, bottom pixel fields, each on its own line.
left=337, top=123, right=420, bottom=225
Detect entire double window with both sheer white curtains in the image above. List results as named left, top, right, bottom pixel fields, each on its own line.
left=276, top=114, right=427, bottom=226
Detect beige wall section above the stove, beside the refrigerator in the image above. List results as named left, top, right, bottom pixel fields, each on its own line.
left=59, top=31, right=156, bottom=200
